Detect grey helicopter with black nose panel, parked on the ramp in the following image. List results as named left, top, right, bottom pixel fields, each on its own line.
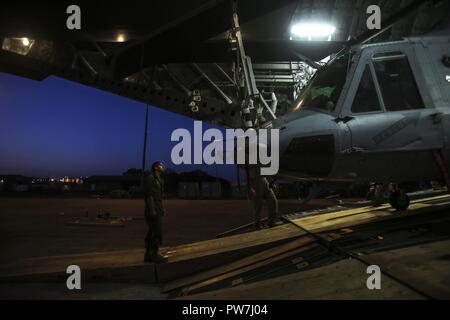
left=270, top=35, right=450, bottom=210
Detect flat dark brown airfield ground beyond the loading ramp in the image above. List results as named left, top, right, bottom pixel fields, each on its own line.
left=0, top=197, right=327, bottom=264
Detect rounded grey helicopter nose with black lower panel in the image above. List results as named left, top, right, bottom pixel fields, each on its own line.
left=274, top=112, right=337, bottom=179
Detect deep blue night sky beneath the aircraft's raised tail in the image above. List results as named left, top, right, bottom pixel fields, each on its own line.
left=0, top=73, right=235, bottom=180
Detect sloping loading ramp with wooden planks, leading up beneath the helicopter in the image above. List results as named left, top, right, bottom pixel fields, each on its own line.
left=0, top=195, right=450, bottom=299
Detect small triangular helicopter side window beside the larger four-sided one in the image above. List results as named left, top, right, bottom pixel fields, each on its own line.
left=352, top=65, right=381, bottom=113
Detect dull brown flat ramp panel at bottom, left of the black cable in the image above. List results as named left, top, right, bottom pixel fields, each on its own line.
left=180, top=260, right=424, bottom=300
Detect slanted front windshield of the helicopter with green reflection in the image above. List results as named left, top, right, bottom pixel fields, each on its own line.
left=292, top=54, right=349, bottom=112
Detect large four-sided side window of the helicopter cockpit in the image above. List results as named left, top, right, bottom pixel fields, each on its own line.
left=373, top=52, right=425, bottom=111
